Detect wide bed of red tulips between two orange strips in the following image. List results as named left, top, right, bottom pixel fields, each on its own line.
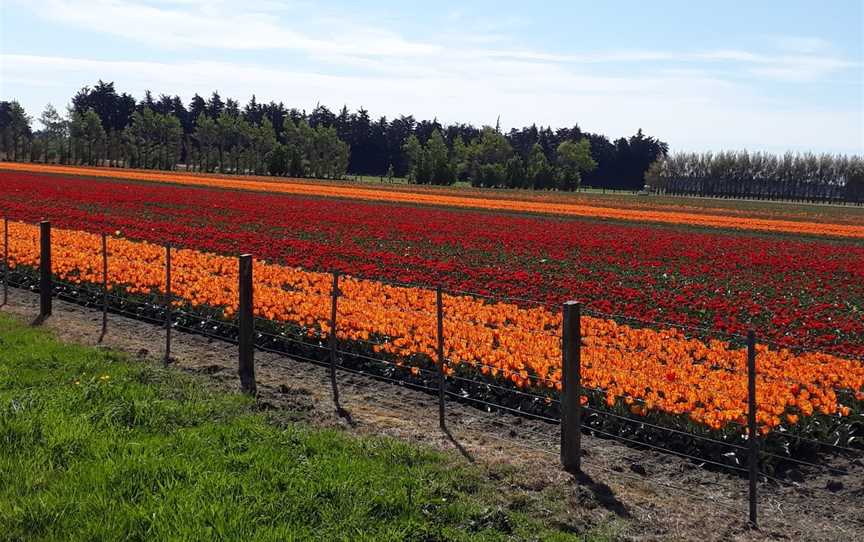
left=0, top=170, right=864, bottom=364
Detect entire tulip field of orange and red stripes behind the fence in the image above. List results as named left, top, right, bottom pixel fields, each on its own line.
left=0, top=164, right=864, bottom=460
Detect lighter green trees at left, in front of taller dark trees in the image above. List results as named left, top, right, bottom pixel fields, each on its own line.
left=0, top=95, right=349, bottom=178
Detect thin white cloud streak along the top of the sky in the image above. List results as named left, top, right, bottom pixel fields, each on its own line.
left=15, top=0, right=860, bottom=81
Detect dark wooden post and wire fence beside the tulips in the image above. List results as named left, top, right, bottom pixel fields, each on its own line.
left=3, top=218, right=860, bottom=527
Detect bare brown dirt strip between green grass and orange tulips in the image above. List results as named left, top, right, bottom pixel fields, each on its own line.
left=0, top=288, right=864, bottom=542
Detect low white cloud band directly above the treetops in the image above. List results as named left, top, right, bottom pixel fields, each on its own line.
left=0, top=55, right=864, bottom=153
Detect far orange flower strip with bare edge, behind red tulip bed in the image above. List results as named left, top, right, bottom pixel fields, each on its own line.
left=0, top=163, right=864, bottom=239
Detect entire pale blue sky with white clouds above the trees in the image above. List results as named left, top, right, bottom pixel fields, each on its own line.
left=0, top=0, right=864, bottom=154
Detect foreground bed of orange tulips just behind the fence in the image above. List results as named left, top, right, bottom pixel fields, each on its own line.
left=3, top=222, right=864, bottom=432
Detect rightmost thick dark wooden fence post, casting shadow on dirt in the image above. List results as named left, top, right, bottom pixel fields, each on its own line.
left=561, top=301, right=582, bottom=474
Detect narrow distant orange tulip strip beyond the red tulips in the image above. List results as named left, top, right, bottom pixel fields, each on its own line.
left=0, top=162, right=864, bottom=239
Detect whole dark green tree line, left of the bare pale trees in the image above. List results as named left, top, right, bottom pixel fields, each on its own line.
left=0, top=80, right=668, bottom=190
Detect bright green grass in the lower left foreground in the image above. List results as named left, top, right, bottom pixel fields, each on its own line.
left=0, top=315, right=614, bottom=540
